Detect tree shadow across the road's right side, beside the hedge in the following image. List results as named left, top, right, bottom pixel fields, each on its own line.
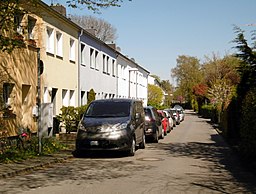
left=147, top=134, right=256, bottom=193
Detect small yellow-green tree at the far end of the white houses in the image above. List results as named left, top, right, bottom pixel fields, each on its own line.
left=148, top=84, right=163, bottom=107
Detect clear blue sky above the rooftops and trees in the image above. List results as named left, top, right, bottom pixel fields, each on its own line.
left=43, top=0, right=256, bottom=83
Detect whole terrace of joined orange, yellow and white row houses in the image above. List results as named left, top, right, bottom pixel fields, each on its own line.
left=0, top=2, right=149, bottom=136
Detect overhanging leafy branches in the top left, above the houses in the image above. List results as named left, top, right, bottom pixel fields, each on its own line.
left=0, top=0, right=128, bottom=53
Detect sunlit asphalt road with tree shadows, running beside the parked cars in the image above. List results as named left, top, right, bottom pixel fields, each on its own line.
left=0, top=111, right=256, bottom=194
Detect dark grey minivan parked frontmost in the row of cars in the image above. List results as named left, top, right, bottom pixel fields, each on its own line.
left=76, top=99, right=145, bottom=156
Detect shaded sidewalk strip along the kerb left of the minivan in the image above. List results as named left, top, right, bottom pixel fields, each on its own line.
left=0, top=150, right=73, bottom=179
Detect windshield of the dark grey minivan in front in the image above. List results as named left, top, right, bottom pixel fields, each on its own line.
left=85, top=101, right=130, bottom=117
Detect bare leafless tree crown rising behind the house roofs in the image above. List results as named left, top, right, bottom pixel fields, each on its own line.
left=71, top=15, right=117, bottom=43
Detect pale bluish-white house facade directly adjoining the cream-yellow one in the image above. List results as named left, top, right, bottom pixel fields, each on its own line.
left=78, top=30, right=117, bottom=105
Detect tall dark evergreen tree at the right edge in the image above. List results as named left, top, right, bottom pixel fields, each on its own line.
left=234, top=27, right=256, bottom=161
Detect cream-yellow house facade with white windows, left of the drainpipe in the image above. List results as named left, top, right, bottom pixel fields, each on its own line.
left=36, top=3, right=80, bottom=116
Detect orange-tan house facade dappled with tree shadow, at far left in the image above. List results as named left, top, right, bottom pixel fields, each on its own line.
left=0, top=36, right=38, bottom=137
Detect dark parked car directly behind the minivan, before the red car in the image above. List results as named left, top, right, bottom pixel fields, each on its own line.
left=144, top=106, right=164, bottom=142
